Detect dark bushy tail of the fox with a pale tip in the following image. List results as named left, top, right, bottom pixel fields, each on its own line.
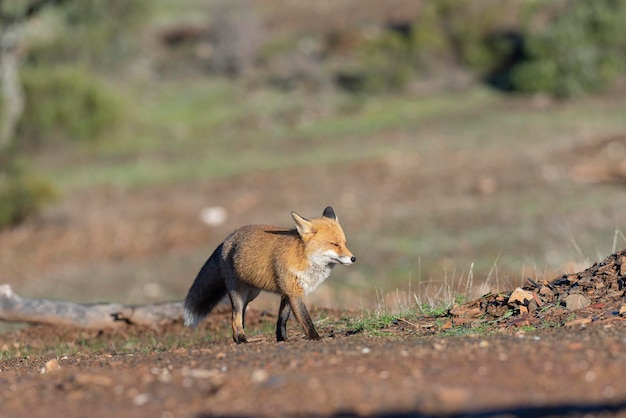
left=183, top=245, right=227, bottom=327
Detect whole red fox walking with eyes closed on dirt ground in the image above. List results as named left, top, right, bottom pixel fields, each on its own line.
left=183, top=206, right=356, bottom=344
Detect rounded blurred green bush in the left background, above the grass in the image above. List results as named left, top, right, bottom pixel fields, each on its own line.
left=18, top=66, right=123, bottom=144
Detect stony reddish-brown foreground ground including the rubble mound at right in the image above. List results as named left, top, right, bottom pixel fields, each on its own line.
left=0, top=248, right=626, bottom=417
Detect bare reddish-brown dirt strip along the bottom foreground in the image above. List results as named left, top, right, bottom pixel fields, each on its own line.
left=0, top=312, right=626, bottom=417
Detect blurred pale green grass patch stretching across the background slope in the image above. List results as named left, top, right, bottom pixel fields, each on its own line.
left=42, top=79, right=496, bottom=190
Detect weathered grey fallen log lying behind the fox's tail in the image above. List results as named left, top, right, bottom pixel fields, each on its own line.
left=0, top=284, right=182, bottom=329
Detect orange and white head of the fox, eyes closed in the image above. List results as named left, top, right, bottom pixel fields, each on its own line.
left=291, top=206, right=356, bottom=265
